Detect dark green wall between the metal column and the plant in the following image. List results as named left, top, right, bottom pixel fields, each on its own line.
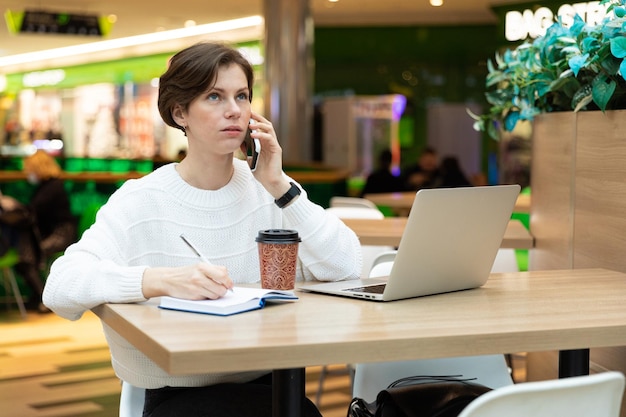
left=314, top=25, right=501, bottom=170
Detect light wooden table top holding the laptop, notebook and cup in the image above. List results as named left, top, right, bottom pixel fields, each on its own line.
left=94, top=269, right=626, bottom=374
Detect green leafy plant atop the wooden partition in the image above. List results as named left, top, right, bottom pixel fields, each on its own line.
left=468, top=0, right=626, bottom=139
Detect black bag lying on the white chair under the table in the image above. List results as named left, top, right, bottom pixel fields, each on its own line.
left=348, top=375, right=491, bottom=417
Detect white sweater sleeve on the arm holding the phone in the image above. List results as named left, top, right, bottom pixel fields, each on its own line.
left=282, top=180, right=363, bottom=281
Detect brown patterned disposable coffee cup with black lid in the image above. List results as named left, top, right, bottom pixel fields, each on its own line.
left=255, top=229, right=301, bottom=290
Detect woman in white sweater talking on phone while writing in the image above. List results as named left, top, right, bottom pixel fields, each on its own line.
left=44, top=43, right=361, bottom=417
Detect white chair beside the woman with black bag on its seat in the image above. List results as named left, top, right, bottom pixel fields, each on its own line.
left=352, top=251, right=513, bottom=402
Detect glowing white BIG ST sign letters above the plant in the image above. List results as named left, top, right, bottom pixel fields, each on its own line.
left=504, top=1, right=607, bottom=42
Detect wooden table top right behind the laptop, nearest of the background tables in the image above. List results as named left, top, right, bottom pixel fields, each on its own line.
left=342, top=217, right=535, bottom=249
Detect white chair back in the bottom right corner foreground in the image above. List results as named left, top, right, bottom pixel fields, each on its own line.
left=459, top=371, right=624, bottom=417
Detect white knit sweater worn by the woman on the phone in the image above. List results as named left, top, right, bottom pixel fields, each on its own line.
left=43, top=160, right=362, bottom=388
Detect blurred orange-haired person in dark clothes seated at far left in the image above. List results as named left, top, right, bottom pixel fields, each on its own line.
left=2, top=150, right=76, bottom=313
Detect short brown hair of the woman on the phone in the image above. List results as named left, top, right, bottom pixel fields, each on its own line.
left=158, top=42, right=254, bottom=132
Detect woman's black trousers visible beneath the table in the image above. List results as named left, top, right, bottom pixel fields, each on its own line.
left=143, top=374, right=322, bottom=417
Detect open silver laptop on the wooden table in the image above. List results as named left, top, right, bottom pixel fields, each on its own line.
left=298, top=185, right=520, bottom=301
